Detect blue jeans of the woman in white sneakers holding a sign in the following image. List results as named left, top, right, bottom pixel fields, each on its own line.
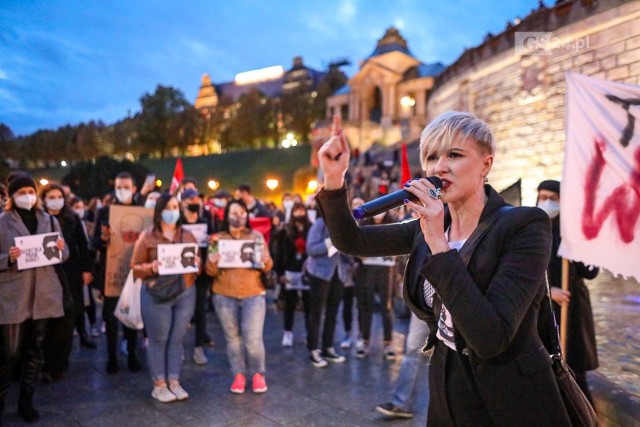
left=140, top=284, right=196, bottom=381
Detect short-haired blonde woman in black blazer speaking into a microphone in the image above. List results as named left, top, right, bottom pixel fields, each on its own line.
left=316, top=112, right=570, bottom=426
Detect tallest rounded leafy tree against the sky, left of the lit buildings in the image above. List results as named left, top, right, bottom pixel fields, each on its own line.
left=137, top=85, right=198, bottom=158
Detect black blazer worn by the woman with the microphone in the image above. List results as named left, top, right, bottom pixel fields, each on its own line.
left=317, top=185, right=570, bottom=426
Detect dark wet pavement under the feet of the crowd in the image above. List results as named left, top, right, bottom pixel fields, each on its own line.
left=3, top=300, right=428, bottom=427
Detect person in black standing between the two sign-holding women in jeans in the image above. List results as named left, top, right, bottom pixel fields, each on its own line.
left=180, top=188, right=214, bottom=365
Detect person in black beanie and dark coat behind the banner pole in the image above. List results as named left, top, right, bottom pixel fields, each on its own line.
left=536, top=179, right=599, bottom=405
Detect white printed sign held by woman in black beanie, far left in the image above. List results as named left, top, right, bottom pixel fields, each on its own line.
left=14, top=232, right=62, bottom=270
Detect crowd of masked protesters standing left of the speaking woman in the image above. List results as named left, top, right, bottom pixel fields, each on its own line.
left=0, top=162, right=420, bottom=421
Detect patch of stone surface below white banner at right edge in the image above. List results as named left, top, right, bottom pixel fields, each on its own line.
left=587, top=271, right=640, bottom=396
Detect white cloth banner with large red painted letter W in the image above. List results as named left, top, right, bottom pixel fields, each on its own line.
left=559, top=73, right=640, bottom=280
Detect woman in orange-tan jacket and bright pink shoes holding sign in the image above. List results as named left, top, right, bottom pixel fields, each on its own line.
left=206, top=200, right=273, bottom=394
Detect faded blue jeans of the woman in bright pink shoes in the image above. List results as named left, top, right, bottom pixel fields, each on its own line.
left=213, top=295, right=267, bottom=375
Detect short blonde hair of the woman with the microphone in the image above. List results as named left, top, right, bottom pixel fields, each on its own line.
left=420, top=111, right=496, bottom=170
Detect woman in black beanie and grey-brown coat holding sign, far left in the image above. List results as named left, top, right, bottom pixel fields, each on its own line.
left=0, top=173, right=69, bottom=422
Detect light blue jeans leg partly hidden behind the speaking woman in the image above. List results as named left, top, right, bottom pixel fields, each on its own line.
left=393, top=313, right=429, bottom=410
